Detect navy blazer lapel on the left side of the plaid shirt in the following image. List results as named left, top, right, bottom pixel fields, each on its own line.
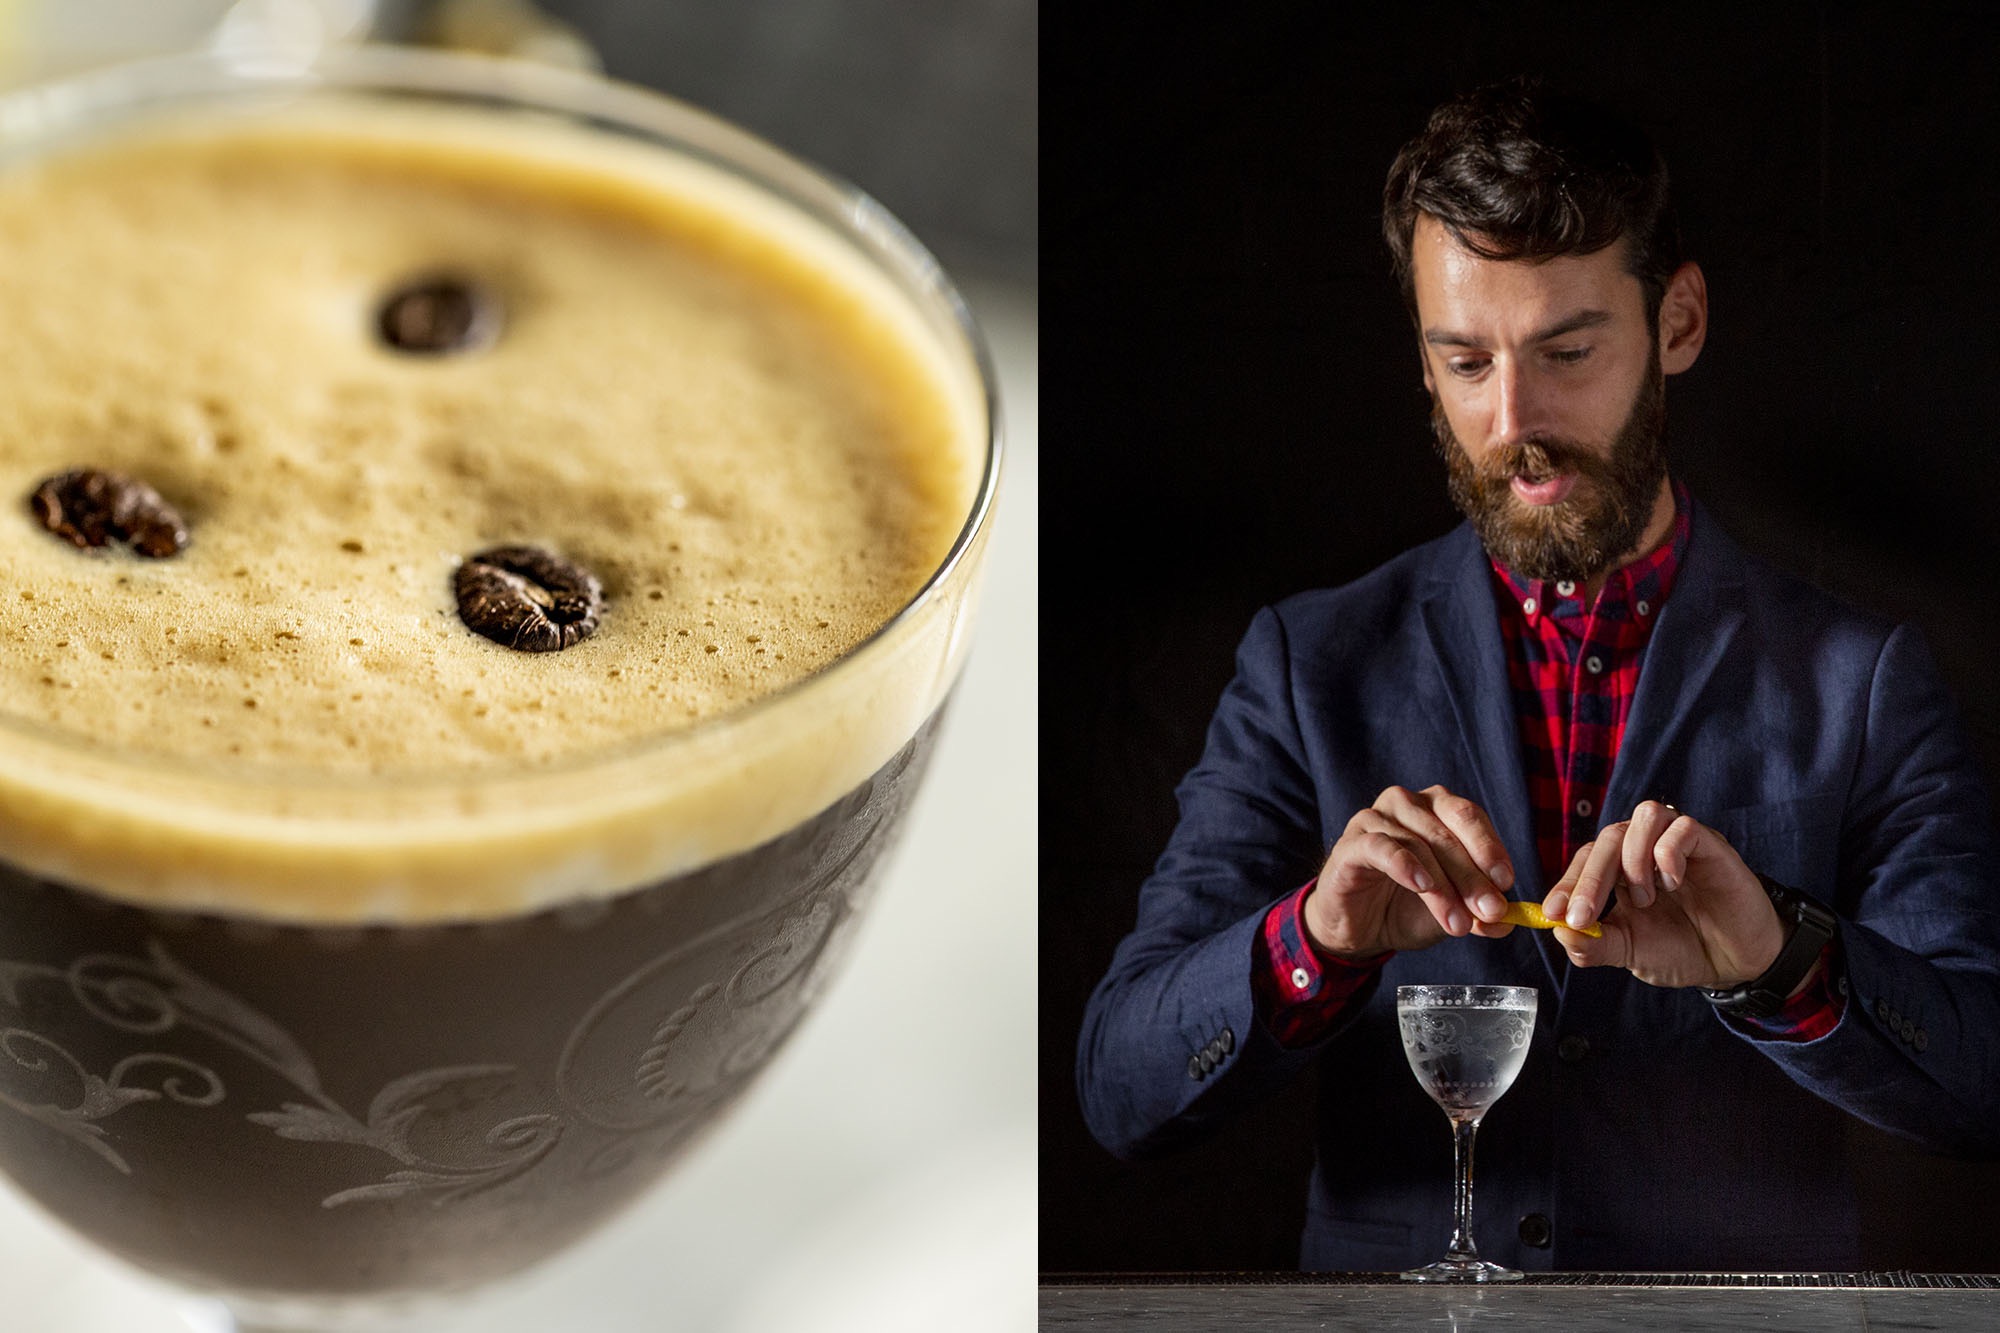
left=1422, top=526, right=1570, bottom=995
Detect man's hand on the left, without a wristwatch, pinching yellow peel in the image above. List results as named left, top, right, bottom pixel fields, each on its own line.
left=1306, top=787, right=1514, bottom=959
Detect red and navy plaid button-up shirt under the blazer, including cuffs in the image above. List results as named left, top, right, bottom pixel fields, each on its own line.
left=1252, top=482, right=1842, bottom=1047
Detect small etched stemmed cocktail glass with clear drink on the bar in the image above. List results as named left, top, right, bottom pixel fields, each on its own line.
left=1396, top=987, right=1536, bottom=1283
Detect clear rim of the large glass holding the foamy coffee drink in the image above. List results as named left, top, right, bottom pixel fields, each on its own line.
left=0, top=44, right=1004, bottom=795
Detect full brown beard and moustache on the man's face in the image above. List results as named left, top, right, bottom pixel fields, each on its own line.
left=1430, top=358, right=1666, bottom=582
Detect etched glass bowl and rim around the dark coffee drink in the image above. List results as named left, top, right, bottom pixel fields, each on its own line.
left=0, top=48, right=1000, bottom=1329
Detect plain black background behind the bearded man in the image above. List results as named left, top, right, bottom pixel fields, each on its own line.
left=1040, top=2, right=2000, bottom=1273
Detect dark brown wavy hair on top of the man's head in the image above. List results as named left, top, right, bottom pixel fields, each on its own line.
left=1382, top=78, right=1682, bottom=324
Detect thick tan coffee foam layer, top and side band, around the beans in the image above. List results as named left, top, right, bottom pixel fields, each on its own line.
left=0, top=98, right=986, bottom=921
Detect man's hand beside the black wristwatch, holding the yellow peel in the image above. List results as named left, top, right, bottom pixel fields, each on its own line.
left=1542, top=801, right=1784, bottom=989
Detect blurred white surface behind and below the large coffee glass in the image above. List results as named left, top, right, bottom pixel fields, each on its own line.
left=0, top=274, right=1038, bottom=1333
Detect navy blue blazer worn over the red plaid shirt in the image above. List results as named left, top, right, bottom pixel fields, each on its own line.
left=1076, top=506, right=2000, bottom=1271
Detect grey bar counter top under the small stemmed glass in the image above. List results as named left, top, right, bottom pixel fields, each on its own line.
left=1040, top=1273, right=2000, bottom=1333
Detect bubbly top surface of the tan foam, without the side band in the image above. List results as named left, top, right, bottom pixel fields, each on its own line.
left=0, top=111, right=964, bottom=773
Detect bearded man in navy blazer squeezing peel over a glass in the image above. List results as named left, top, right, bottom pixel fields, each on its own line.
left=1078, top=82, right=2000, bottom=1271
